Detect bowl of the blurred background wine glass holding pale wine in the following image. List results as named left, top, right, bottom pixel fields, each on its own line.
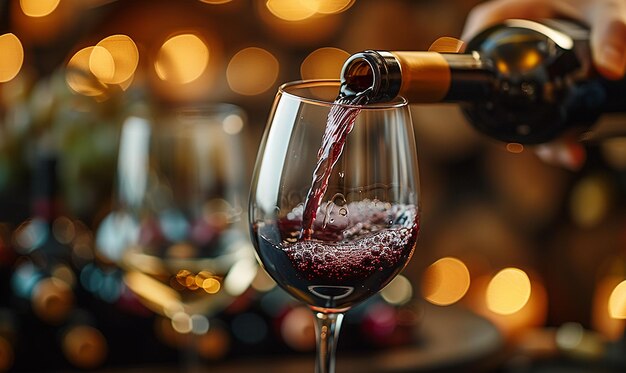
left=98, top=104, right=258, bottom=334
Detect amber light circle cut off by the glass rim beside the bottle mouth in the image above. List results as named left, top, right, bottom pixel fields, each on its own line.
left=300, top=47, right=350, bottom=80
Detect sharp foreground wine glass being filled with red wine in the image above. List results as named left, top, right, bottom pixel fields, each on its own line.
left=249, top=80, right=419, bottom=373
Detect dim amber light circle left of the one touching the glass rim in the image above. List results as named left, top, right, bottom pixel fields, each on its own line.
left=226, top=47, right=279, bottom=96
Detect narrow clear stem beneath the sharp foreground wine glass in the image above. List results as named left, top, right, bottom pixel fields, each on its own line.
left=313, top=311, right=343, bottom=373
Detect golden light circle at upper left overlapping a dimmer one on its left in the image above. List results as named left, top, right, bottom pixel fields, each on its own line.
left=89, top=35, right=139, bottom=84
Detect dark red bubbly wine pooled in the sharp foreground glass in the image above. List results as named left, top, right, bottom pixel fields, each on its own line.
left=255, top=200, right=419, bottom=309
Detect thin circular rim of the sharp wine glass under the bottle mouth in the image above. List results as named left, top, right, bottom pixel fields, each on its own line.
left=278, top=79, right=409, bottom=110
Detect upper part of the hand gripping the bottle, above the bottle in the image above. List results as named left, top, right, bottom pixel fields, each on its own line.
left=461, top=0, right=626, bottom=79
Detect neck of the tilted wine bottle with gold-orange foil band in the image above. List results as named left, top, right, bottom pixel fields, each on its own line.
left=341, top=51, right=493, bottom=103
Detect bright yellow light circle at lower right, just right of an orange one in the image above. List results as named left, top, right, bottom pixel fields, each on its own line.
left=486, top=268, right=531, bottom=315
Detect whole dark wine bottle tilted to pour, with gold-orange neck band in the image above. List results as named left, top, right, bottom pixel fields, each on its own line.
left=340, top=19, right=626, bottom=144
